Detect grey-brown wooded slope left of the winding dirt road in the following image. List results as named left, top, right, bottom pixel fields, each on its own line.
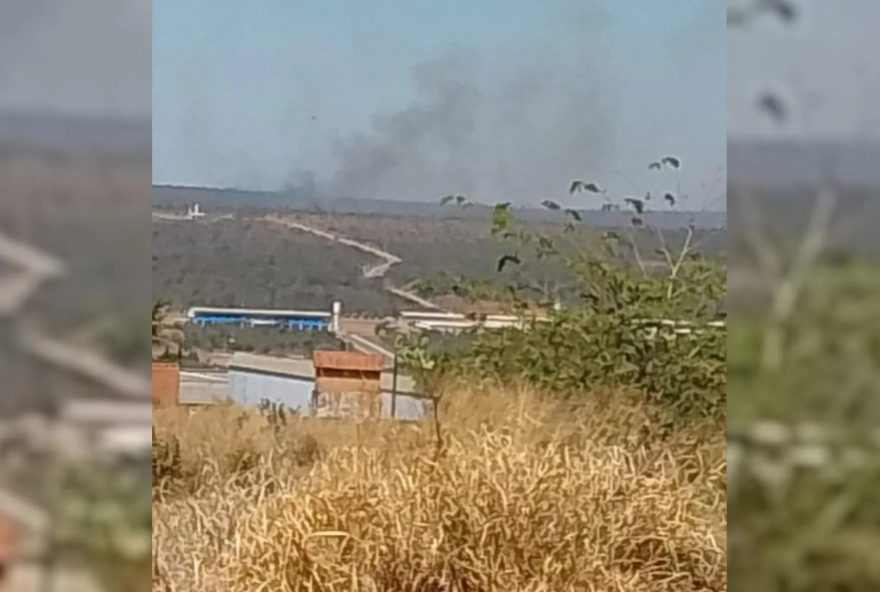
left=153, top=219, right=394, bottom=314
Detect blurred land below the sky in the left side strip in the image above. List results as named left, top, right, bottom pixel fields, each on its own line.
left=0, top=112, right=151, bottom=592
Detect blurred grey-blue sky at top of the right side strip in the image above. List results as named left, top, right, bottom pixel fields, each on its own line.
left=728, top=0, right=880, bottom=142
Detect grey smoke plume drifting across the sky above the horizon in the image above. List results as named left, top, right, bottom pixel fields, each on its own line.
left=329, top=51, right=615, bottom=204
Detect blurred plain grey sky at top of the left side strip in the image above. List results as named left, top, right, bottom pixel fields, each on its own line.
left=0, top=0, right=151, bottom=120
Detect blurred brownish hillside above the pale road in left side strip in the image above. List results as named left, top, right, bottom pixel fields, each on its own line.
left=0, top=139, right=151, bottom=369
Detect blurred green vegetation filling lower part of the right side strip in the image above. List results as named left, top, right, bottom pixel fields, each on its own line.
left=728, top=190, right=880, bottom=592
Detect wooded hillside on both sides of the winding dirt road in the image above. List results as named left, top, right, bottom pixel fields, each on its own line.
left=153, top=210, right=724, bottom=315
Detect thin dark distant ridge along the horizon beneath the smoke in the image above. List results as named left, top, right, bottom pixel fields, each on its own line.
left=153, top=185, right=727, bottom=229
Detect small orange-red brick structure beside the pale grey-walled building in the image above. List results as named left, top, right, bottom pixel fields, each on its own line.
left=313, top=351, right=383, bottom=417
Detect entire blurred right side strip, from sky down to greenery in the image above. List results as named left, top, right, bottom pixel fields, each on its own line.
left=728, top=0, right=880, bottom=592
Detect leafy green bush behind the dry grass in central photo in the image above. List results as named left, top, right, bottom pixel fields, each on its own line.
left=398, top=185, right=727, bottom=420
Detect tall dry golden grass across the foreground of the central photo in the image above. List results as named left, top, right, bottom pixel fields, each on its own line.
left=153, top=392, right=727, bottom=592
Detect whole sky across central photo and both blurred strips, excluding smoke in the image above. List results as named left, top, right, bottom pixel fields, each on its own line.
left=0, top=0, right=880, bottom=199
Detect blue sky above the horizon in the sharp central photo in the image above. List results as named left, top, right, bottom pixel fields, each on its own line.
left=152, top=0, right=727, bottom=208
